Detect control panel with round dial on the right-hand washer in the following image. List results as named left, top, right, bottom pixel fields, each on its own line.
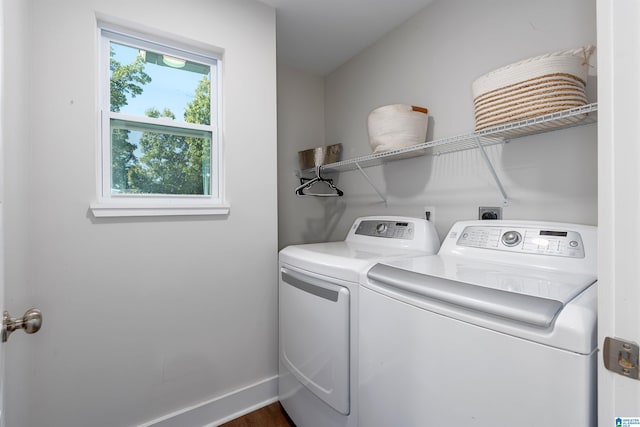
left=457, top=225, right=584, bottom=258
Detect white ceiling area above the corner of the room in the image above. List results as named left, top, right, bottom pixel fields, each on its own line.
left=261, top=0, right=433, bottom=76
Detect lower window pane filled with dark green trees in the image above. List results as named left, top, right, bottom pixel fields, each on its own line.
left=111, top=119, right=211, bottom=196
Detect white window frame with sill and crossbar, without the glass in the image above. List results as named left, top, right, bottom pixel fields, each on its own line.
left=90, top=23, right=230, bottom=217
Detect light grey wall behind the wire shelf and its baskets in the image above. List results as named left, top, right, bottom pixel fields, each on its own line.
left=280, top=0, right=597, bottom=244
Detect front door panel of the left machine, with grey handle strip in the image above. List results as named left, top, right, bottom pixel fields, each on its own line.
left=279, top=267, right=350, bottom=415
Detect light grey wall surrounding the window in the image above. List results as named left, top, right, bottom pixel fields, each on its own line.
left=3, top=0, right=277, bottom=427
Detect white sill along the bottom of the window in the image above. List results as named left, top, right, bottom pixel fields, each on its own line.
left=90, top=203, right=231, bottom=218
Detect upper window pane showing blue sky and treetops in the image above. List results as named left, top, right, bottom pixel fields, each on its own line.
left=109, top=41, right=211, bottom=125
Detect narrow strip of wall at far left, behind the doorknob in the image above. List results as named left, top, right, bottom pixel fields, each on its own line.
left=2, top=0, right=35, bottom=427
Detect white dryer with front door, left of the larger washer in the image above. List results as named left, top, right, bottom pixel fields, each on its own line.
left=278, top=216, right=439, bottom=427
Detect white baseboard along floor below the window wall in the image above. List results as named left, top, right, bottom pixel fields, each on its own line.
left=137, top=375, right=278, bottom=427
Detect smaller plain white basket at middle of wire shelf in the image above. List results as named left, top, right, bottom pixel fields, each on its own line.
left=367, top=104, right=429, bottom=153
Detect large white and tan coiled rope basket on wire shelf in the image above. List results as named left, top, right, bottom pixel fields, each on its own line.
left=471, top=46, right=594, bottom=131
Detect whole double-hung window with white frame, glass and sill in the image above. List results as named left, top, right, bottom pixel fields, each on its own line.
left=92, top=24, right=228, bottom=216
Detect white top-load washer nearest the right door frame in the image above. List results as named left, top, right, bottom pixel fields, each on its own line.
left=358, top=221, right=597, bottom=427
